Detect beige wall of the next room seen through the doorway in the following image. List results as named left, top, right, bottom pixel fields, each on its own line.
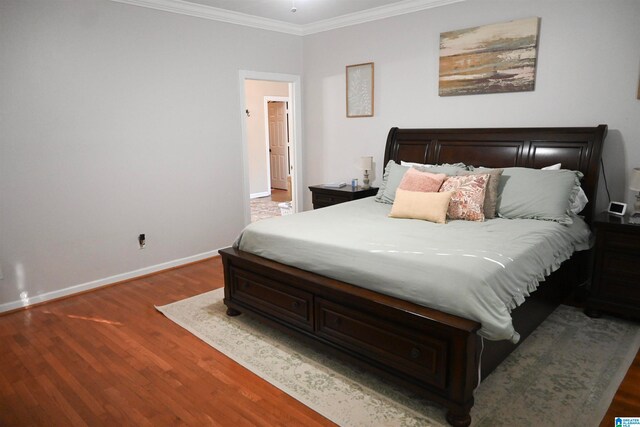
left=245, top=80, right=289, bottom=194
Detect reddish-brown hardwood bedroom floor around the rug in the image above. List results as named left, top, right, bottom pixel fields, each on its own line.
left=0, top=258, right=640, bottom=427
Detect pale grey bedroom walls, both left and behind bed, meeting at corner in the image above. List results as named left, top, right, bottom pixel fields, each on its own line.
left=0, top=0, right=640, bottom=311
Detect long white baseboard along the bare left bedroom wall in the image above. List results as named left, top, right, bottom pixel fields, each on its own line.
left=0, top=249, right=218, bottom=313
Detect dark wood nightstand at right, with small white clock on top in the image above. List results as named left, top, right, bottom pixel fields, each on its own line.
left=585, top=213, right=640, bottom=318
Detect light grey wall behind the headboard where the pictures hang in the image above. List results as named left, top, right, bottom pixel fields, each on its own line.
left=303, top=0, right=640, bottom=212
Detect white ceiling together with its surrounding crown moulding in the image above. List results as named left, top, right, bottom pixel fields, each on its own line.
left=111, top=0, right=464, bottom=35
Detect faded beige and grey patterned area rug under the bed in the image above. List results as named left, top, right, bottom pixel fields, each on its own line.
left=156, top=289, right=640, bottom=426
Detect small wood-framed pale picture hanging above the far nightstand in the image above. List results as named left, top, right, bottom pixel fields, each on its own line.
left=346, top=62, right=373, bottom=117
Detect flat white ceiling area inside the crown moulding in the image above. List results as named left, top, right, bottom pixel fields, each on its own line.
left=188, top=0, right=416, bottom=25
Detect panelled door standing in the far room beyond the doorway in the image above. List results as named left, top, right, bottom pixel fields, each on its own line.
left=267, top=101, right=289, bottom=190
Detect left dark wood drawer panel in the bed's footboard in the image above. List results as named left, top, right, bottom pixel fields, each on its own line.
left=229, top=267, right=313, bottom=331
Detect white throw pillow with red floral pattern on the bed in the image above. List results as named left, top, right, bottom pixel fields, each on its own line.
left=440, top=174, right=489, bottom=221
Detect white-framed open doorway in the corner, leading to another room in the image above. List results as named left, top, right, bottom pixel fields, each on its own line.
left=240, top=71, right=303, bottom=224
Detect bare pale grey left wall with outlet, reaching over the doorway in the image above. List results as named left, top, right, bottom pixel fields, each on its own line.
left=0, top=0, right=302, bottom=310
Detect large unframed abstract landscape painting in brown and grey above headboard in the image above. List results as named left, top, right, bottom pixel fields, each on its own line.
left=439, top=17, right=540, bottom=96
